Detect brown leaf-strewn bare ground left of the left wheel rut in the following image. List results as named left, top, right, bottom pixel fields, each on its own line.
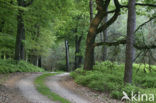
left=0, top=73, right=31, bottom=103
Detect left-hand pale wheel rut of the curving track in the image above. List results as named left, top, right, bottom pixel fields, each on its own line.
left=16, top=73, right=58, bottom=103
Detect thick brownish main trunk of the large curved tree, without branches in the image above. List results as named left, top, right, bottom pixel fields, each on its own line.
left=84, top=12, right=106, bottom=70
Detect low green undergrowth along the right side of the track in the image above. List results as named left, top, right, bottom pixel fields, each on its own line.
left=71, top=61, right=156, bottom=103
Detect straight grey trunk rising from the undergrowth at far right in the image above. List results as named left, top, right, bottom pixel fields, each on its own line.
left=124, top=0, right=136, bottom=83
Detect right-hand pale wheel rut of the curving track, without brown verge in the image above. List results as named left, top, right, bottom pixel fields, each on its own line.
left=46, top=73, right=92, bottom=103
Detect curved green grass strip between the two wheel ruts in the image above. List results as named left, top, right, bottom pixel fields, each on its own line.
left=34, top=73, right=70, bottom=103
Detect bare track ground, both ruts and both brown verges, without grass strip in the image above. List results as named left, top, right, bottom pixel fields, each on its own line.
left=0, top=73, right=120, bottom=103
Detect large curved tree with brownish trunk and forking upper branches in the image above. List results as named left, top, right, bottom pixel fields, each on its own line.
left=84, top=0, right=120, bottom=70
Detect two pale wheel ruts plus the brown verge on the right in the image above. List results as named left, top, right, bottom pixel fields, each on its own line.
left=15, top=73, right=120, bottom=103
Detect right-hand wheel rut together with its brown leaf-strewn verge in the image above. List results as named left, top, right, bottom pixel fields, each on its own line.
left=46, top=73, right=121, bottom=103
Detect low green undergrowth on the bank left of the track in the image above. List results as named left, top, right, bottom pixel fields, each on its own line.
left=0, top=60, right=44, bottom=74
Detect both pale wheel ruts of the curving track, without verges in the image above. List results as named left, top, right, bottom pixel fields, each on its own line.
left=16, top=73, right=92, bottom=103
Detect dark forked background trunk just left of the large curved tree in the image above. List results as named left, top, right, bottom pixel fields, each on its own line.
left=75, top=35, right=82, bottom=69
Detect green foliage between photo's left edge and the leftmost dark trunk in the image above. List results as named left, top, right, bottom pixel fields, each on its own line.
left=0, top=0, right=19, bottom=59
